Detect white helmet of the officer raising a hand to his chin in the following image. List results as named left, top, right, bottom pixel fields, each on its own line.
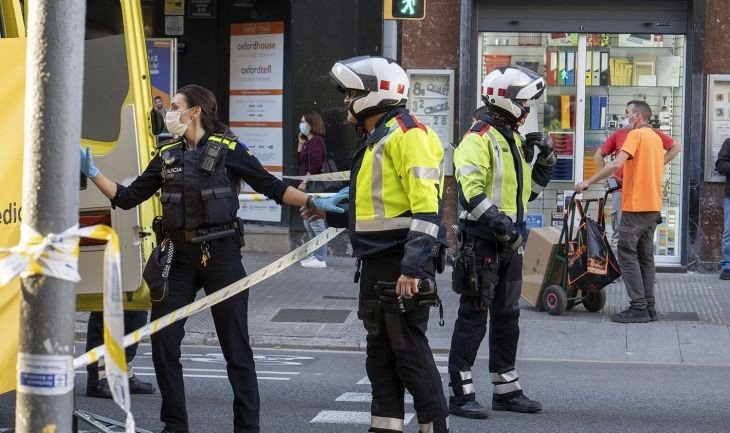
left=482, top=65, right=545, bottom=121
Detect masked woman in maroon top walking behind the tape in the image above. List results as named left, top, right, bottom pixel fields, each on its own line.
left=297, top=112, right=327, bottom=268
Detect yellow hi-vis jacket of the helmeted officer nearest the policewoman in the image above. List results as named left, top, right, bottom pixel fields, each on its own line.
left=327, top=108, right=445, bottom=277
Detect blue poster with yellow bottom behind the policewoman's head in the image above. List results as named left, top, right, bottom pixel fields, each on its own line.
left=146, top=38, right=177, bottom=113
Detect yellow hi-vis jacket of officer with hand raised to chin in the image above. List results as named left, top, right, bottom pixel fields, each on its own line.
left=454, top=121, right=534, bottom=239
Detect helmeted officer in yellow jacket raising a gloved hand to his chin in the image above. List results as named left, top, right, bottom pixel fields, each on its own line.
left=449, top=66, right=556, bottom=418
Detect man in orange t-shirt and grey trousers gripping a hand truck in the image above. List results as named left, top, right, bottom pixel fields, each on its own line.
left=575, top=101, right=665, bottom=323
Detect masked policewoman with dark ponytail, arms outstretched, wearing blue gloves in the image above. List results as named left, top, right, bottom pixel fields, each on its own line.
left=81, top=85, right=328, bottom=433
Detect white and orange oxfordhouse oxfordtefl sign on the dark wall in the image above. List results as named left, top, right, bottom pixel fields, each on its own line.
left=229, top=21, right=284, bottom=222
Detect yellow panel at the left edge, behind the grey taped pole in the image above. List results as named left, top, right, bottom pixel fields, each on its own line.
left=0, top=38, right=26, bottom=394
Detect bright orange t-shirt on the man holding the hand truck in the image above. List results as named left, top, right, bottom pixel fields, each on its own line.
left=621, top=128, right=664, bottom=212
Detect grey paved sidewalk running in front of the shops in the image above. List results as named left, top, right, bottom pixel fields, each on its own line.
left=76, top=253, right=730, bottom=365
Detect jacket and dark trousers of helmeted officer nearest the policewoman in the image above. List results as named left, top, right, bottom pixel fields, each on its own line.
left=327, top=108, right=448, bottom=433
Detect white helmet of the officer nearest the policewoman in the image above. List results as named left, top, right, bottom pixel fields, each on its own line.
left=330, top=56, right=410, bottom=121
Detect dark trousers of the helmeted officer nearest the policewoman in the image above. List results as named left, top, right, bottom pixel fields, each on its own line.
left=359, top=250, right=448, bottom=433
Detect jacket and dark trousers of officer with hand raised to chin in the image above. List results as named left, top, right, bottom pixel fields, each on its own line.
left=449, top=116, right=552, bottom=408
